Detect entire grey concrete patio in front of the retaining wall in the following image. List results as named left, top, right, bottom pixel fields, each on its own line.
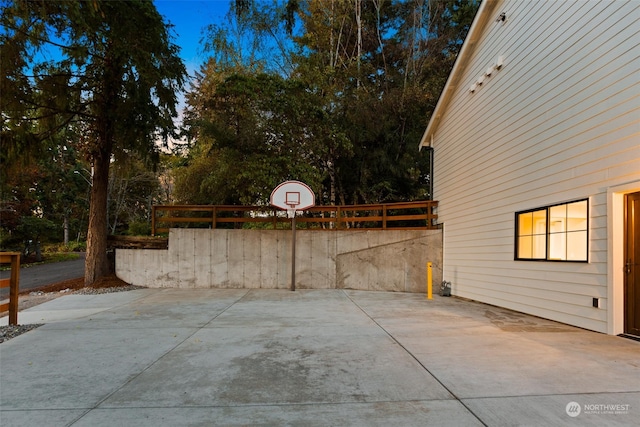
left=0, top=289, right=640, bottom=427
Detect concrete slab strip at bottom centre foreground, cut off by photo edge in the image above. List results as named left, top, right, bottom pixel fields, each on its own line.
left=73, top=400, right=483, bottom=427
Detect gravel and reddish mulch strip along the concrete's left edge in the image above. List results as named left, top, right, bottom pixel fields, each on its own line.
left=0, top=276, right=144, bottom=343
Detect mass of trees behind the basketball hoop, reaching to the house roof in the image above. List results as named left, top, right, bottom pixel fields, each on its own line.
left=175, top=0, right=479, bottom=204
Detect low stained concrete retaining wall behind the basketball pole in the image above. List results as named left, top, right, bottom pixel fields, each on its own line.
left=116, top=229, right=442, bottom=292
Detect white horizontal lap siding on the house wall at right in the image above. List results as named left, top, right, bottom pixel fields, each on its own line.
left=433, top=0, right=640, bottom=332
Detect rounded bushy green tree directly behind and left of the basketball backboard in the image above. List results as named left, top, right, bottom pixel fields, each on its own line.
left=176, top=66, right=321, bottom=204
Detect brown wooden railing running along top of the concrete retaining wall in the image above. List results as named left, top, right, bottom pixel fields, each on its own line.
left=151, top=200, right=438, bottom=236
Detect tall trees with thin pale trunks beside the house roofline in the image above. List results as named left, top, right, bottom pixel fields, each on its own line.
left=295, top=0, right=478, bottom=203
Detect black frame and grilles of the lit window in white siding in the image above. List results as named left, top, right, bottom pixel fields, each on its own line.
left=513, top=198, right=590, bottom=263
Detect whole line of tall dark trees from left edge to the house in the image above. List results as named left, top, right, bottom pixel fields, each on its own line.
left=0, top=0, right=479, bottom=284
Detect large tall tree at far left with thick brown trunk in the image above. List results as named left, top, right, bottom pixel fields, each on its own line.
left=0, top=0, right=186, bottom=284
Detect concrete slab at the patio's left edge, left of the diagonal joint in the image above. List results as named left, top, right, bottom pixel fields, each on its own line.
left=0, top=325, right=193, bottom=412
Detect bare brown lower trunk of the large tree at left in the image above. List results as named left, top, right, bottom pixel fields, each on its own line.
left=84, top=151, right=110, bottom=286
